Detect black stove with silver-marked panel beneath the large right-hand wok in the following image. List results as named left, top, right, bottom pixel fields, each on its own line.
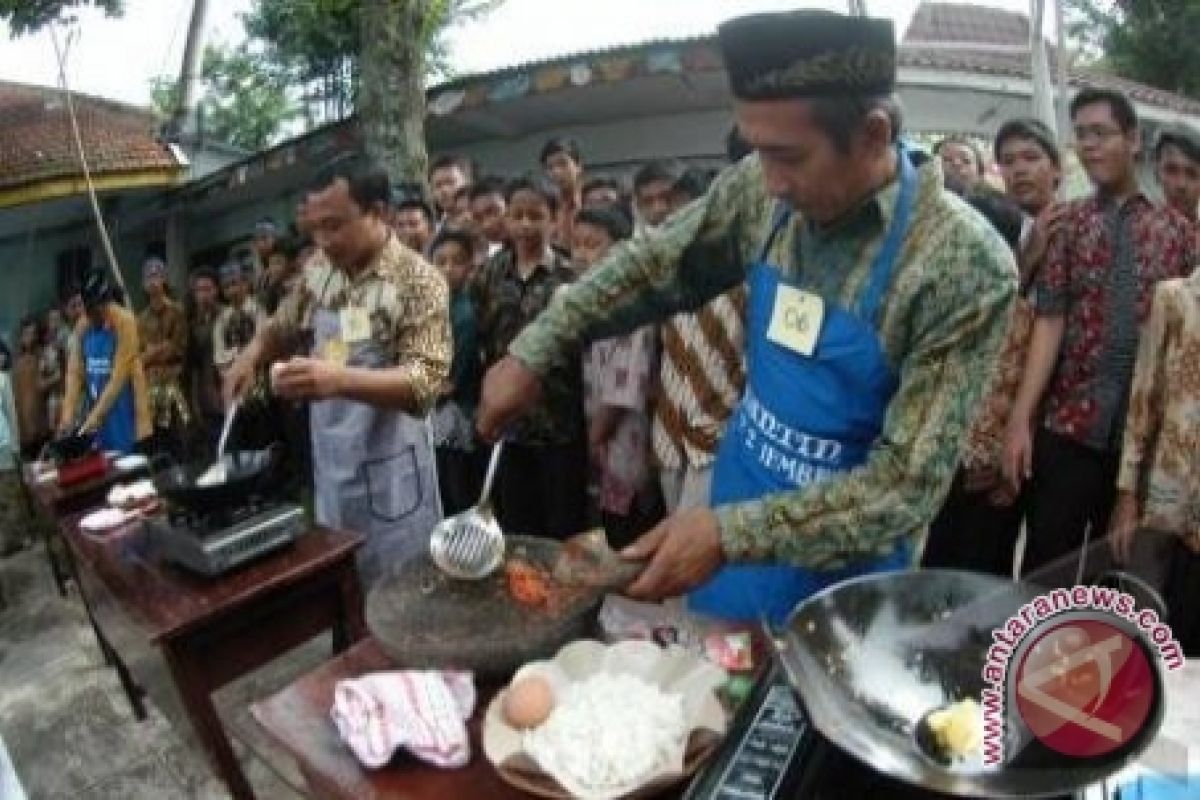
left=683, top=660, right=1082, bottom=800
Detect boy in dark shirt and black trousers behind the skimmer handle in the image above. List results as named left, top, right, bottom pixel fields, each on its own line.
left=476, top=178, right=587, bottom=539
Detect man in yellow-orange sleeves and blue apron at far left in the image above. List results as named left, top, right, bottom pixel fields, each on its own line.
left=59, top=269, right=152, bottom=453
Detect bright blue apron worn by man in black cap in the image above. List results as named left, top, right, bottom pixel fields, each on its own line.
left=688, top=150, right=917, bottom=624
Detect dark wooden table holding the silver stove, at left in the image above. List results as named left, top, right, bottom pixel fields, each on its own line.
left=61, top=516, right=366, bottom=800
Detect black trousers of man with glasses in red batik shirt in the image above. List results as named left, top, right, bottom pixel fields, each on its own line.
left=1021, top=428, right=1120, bottom=575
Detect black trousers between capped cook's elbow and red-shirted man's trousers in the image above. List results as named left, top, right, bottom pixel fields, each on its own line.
left=920, top=469, right=1025, bottom=578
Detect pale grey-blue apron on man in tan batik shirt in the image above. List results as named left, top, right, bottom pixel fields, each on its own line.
left=310, top=303, right=442, bottom=587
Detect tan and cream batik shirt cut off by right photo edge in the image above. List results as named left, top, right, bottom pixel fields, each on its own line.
left=1117, top=272, right=1200, bottom=544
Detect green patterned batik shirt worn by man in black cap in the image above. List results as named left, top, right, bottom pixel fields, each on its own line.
left=511, top=156, right=1016, bottom=569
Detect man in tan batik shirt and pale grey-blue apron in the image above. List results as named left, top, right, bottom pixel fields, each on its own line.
left=226, top=161, right=450, bottom=584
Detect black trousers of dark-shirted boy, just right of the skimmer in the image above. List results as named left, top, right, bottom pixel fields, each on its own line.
left=496, top=438, right=588, bottom=539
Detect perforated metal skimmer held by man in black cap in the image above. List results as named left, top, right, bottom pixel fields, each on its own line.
left=430, top=439, right=504, bottom=581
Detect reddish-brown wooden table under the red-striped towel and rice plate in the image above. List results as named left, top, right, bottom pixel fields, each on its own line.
left=250, top=638, right=686, bottom=800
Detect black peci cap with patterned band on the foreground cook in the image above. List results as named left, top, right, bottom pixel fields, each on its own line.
left=718, top=10, right=896, bottom=101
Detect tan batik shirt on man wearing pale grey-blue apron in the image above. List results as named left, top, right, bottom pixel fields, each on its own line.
left=271, top=234, right=451, bottom=416
